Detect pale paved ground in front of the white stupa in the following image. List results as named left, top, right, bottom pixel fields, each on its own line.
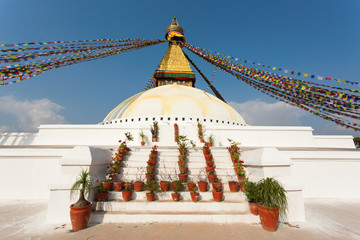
left=0, top=199, right=360, bottom=240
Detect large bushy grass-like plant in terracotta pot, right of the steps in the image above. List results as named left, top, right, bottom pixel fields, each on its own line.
left=257, top=178, right=287, bottom=232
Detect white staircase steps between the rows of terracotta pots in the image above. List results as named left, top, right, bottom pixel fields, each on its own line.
left=90, top=147, right=259, bottom=223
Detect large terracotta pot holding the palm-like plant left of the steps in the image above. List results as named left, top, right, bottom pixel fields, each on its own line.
left=70, top=203, right=92, bottom=231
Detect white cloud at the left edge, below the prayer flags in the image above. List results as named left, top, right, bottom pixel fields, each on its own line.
left=0, top=96, right=66, bottom=132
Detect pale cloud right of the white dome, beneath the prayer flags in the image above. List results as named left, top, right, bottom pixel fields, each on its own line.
left=229, top=100, right=307, bottom=126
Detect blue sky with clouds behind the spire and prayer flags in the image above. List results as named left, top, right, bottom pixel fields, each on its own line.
left=0, top=0, right=360, bottom=136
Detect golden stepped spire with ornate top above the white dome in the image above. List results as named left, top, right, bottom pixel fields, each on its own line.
left=154, top=17, right=195, bottom=87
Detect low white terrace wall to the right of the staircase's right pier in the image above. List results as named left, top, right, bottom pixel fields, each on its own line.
left=287, top=150, right=360, bottom=198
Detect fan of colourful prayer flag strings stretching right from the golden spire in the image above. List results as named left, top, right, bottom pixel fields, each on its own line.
left=185, top=44, right=360, bottom=131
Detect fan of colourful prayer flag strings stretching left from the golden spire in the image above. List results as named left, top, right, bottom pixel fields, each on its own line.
left=0, top=39, right=166, bottom=85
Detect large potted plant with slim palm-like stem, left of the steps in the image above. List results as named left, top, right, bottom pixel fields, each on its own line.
left=70, top=170, right=93, bottom=231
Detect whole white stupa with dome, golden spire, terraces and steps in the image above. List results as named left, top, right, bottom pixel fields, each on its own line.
left=0, top=19, right=360, bottom=225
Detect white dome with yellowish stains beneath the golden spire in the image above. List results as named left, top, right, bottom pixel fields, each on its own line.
left=104, top=84, right=246, bottom=125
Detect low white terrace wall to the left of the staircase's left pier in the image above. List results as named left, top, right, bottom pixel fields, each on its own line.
left=0, top=147, right=69, bottom=199
